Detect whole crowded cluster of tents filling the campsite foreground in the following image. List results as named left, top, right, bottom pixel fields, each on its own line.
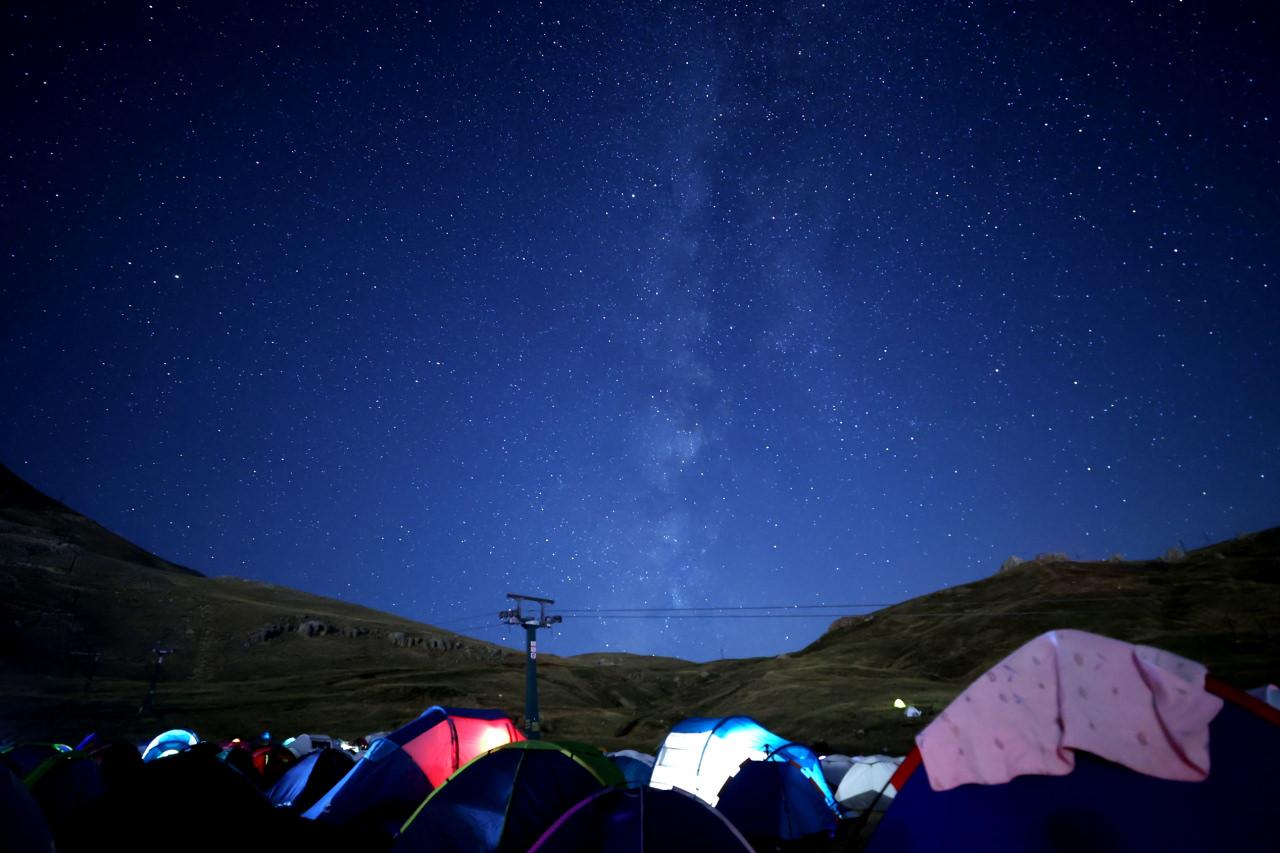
left=0, top=631, right=1280, bottom=853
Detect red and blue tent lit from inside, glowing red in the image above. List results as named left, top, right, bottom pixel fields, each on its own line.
left=303, top=706, right=524, bottom=835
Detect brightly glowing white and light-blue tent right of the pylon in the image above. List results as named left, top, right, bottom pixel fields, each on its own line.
left=649, top=717, right=836, bottom=811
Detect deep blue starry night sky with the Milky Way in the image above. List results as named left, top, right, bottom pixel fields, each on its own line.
left=0, top=0, right=1280, bottom=660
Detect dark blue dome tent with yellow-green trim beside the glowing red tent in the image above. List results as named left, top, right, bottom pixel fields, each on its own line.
left=392, top=740, right=625, bottom=853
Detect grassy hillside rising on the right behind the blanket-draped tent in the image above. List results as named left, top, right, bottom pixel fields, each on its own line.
left=714, top=528, right=1280, bottom=751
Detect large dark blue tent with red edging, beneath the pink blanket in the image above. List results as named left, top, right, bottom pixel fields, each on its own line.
left=867, top=678, right=1280, bottom=853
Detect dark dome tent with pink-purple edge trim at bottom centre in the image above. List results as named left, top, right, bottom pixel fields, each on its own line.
left=531, top=788, right=751, bottom=853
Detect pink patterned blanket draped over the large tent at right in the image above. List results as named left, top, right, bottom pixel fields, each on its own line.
left=915, top=630, right=1222, bottom=790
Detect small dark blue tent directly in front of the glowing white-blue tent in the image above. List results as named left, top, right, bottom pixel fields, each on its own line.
left=716, top=752, right=838, bottom=848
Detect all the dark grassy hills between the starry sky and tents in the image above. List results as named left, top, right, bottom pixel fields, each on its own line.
left=0, top=466, right=1280, bottom=752
